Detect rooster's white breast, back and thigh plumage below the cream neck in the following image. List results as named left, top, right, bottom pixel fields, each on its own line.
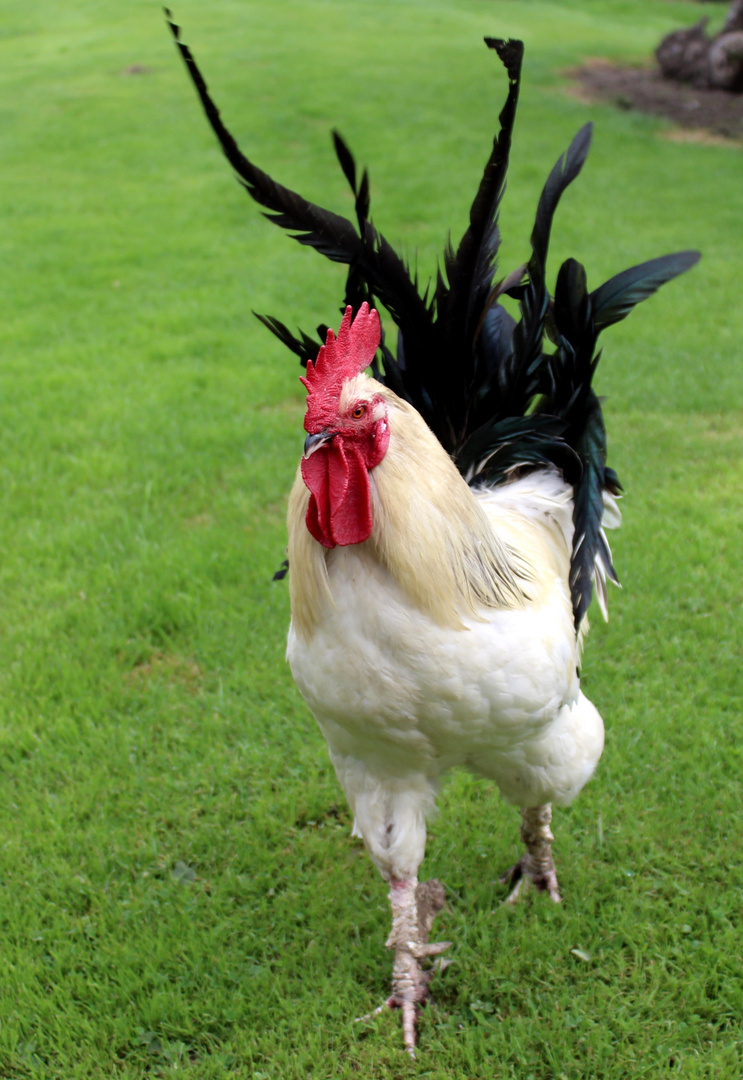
left=287, top=472, right=604, bottom=876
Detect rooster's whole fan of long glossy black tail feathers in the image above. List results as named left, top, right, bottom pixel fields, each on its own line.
left=166, top=12, right=699, bottom=627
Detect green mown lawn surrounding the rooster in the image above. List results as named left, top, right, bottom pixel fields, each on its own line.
left=0, top=0, right=743, bottom=1080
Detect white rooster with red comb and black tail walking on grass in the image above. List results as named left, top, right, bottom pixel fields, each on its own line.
left=171, top=21, right=699, bottom=1054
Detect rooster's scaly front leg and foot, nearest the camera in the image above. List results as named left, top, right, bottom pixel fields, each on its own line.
left=360, top=878, right=451, bottom=1057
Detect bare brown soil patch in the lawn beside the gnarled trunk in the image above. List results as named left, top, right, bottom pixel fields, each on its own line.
left=567, top=59, right=743, bottom=141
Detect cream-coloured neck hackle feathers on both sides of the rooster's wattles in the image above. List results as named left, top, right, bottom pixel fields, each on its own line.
left=288, top=378, right=531, bottom=637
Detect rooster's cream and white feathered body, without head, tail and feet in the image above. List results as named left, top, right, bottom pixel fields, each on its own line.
left=287, top=388, right=604, bottom=879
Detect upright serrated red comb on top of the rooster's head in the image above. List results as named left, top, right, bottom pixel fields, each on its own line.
left=300, top=301, right=381, bottom=431
